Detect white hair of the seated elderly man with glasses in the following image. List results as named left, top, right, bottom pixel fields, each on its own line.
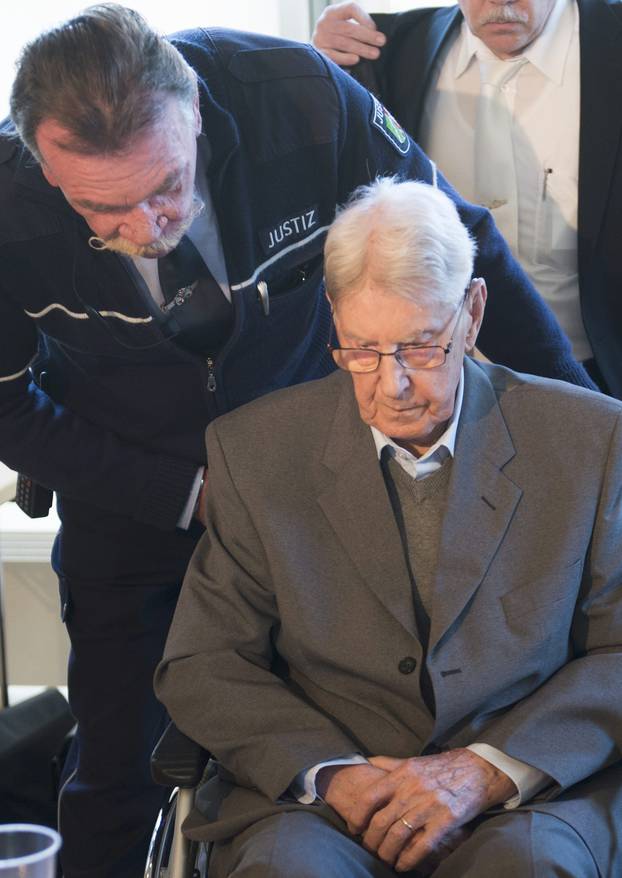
left=324, top=177, right=476, bottom=306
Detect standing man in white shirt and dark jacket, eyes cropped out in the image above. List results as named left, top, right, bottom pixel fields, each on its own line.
left=314, top=0, right=622, bottom=397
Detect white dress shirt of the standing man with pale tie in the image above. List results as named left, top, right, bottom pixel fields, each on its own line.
left=419, top=0, right=592, bottom=360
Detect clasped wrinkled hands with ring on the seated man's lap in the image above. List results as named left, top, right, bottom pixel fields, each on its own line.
left=316, top=749, right=516, bottom=874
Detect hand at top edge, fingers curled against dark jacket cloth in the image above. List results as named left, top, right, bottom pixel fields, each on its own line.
left=312, top=2, right=386, bottom=67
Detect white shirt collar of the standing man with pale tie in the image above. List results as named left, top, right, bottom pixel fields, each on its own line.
left=453, top=0, right=579, bottom=85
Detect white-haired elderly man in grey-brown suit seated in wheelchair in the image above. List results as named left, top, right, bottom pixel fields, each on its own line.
left=152, top=180, right=622, bottom=878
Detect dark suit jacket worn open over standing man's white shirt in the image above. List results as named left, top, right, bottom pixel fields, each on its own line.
left=352, top=0, right=622, bottom=399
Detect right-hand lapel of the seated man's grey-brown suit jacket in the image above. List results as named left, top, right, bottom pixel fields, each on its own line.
left=429, top=360, right=522, bottom=654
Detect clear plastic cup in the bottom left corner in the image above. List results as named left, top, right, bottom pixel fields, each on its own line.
left=0, top=823, right=61, bottom=878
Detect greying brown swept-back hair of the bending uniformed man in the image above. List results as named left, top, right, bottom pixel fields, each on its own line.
left=11, top=3, right=197, bottom=160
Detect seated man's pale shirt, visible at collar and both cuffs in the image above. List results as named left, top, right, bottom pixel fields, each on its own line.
left=292, top=369, right=550, bottom=809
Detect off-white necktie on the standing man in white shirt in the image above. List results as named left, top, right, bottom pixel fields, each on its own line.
left=475, top=58, right=527, bottom=253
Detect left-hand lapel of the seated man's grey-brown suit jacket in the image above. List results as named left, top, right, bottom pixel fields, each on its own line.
left=318, top=375, right=415, bottom=634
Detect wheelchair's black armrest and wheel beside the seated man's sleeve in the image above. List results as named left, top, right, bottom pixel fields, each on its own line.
left=144, top=723, right=210, bottom=878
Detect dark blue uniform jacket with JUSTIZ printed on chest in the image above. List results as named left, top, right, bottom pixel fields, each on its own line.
left=0, top=30, right=589, bottom=529
